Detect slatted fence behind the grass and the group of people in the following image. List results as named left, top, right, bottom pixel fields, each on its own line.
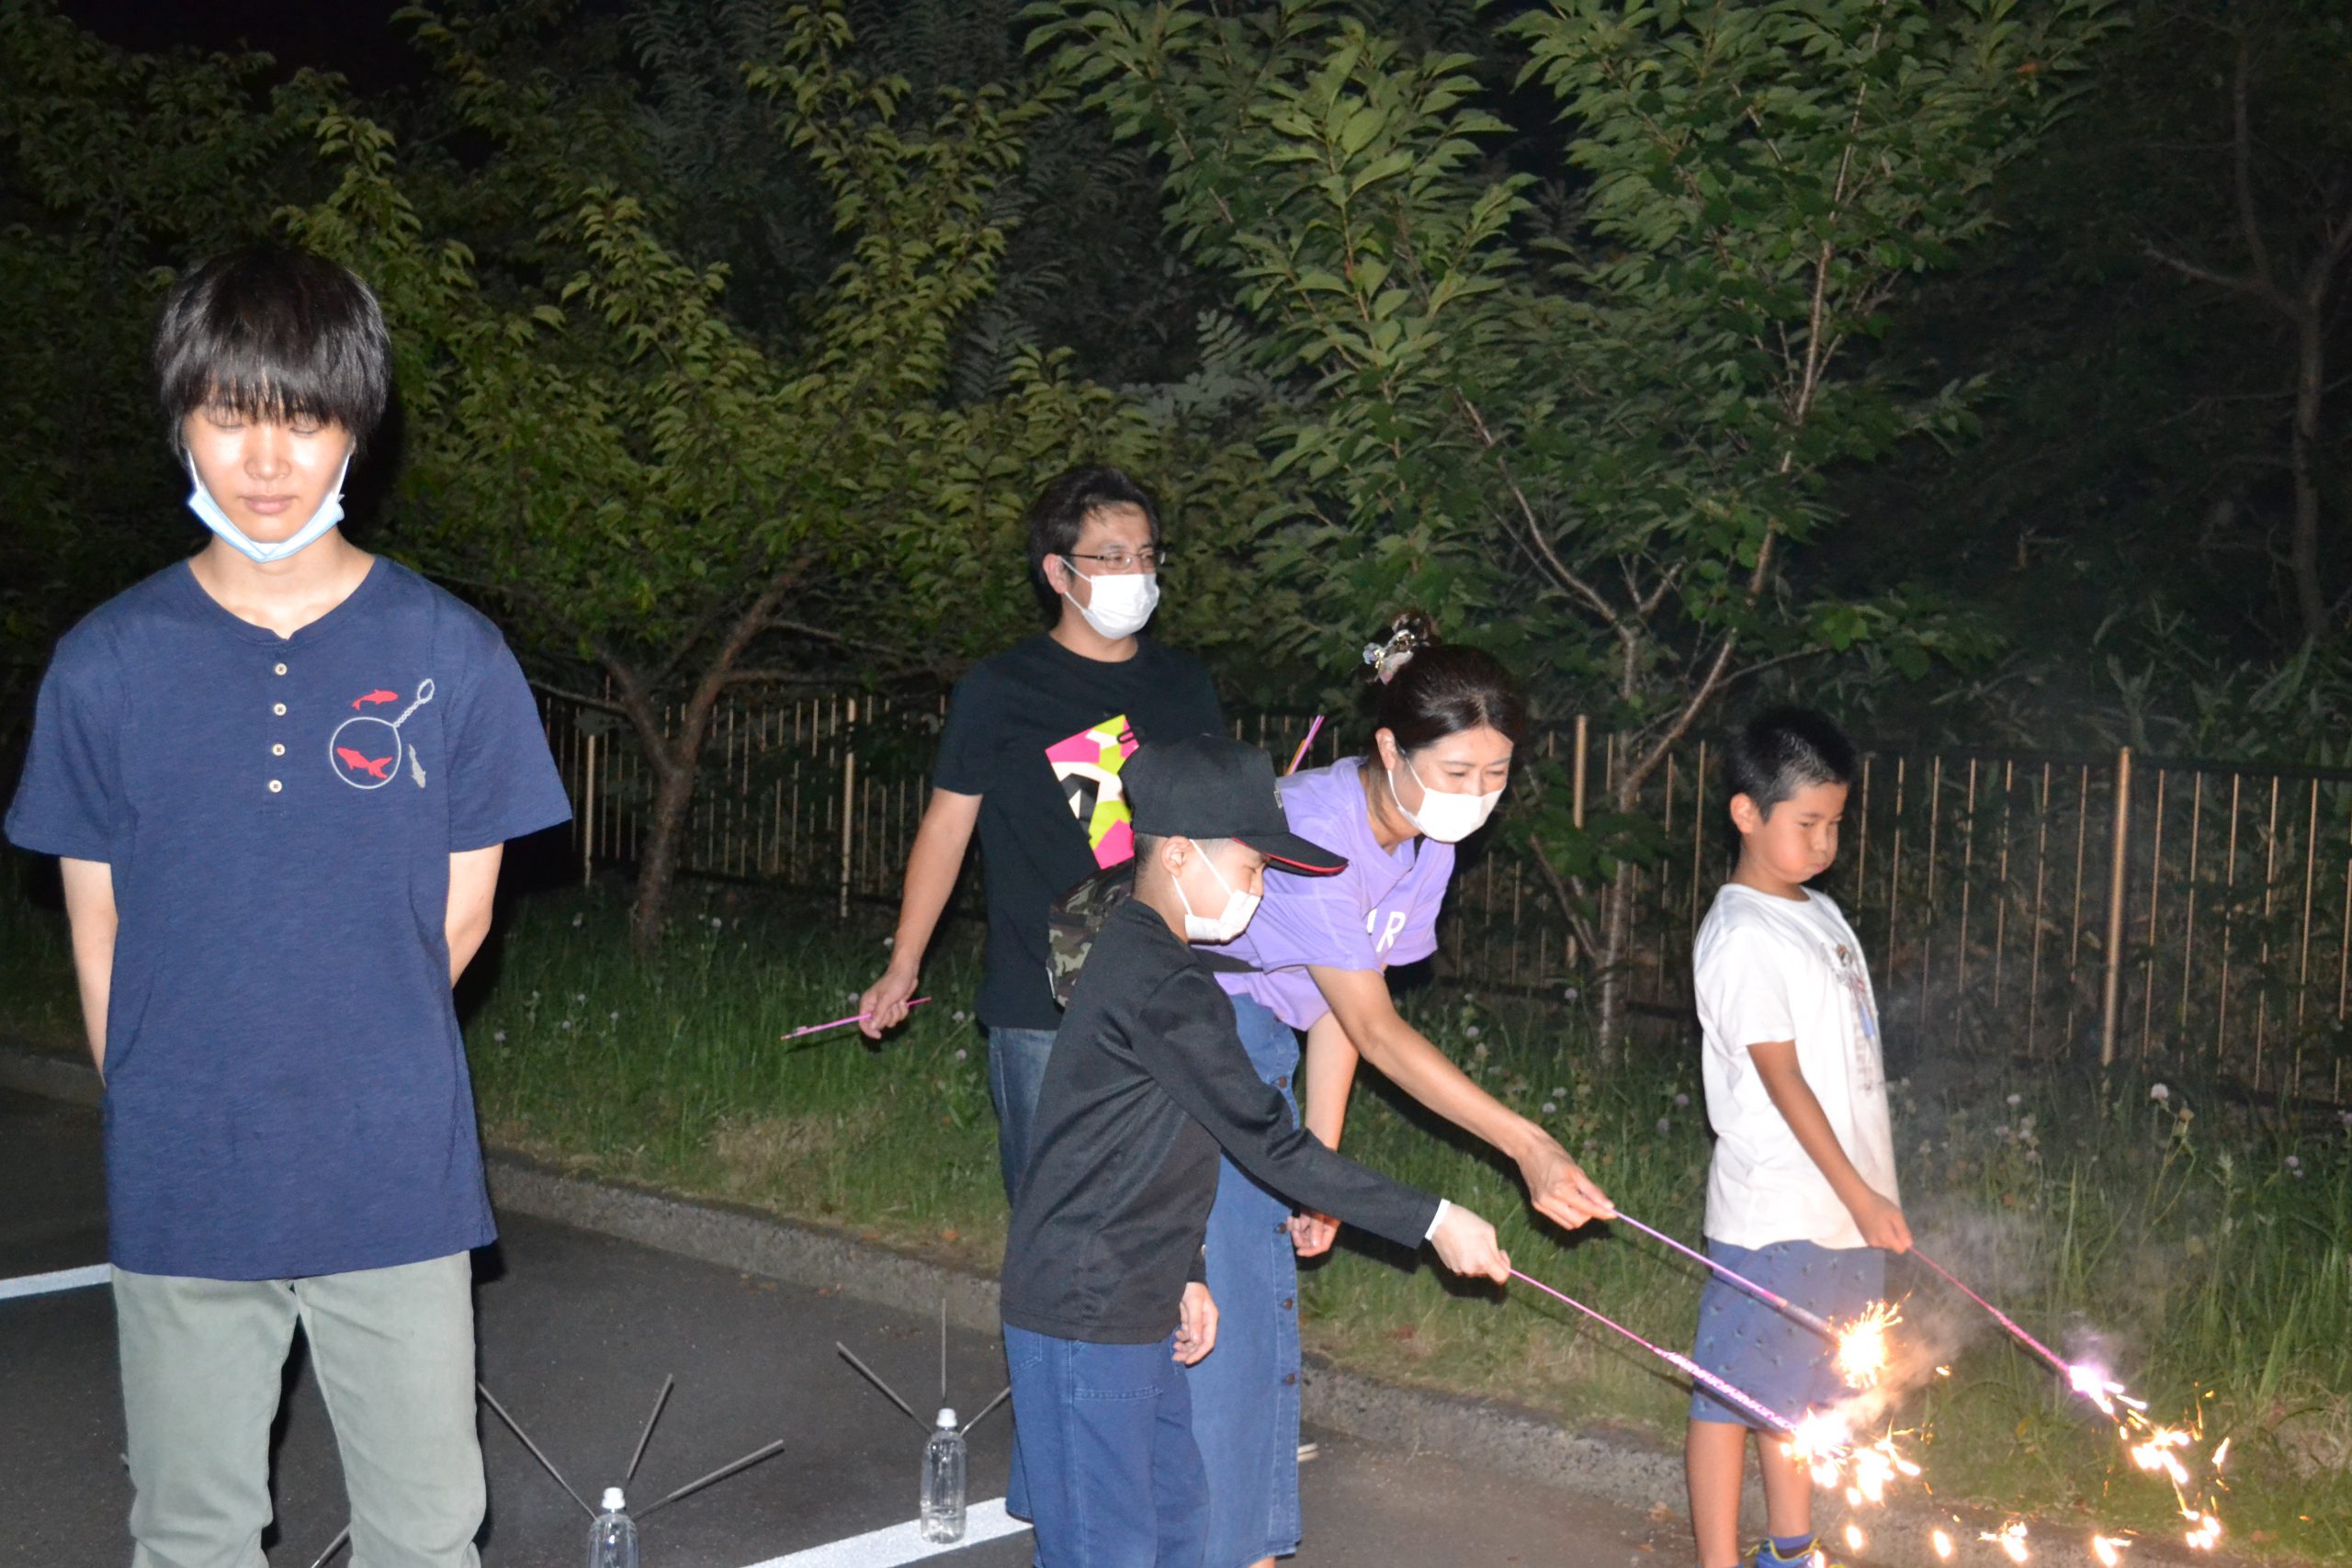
left=546, top=694, right=2352, bottom=1102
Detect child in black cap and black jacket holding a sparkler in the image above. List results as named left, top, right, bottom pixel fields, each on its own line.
left=1004, top=736, right=1510, bottom=1568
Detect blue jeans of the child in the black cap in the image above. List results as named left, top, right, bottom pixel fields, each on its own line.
left=1004, top=1324, right=1214, bottom=1568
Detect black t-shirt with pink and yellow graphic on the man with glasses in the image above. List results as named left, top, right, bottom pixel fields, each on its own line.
left=932, top=635, right=1223, bottom=1030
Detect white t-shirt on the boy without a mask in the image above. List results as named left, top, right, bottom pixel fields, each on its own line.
left=1691, top=884, right=1900, bottom=1246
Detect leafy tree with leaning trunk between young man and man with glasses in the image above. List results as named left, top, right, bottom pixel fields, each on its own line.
left=0, top=0, right=1288, bottom=945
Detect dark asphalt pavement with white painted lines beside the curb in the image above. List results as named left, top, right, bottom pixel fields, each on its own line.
left=0, top=1093, right=1689, bottom=1568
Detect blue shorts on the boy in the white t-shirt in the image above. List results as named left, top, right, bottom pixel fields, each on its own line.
left=1691, top=1236, right=1886, bottom=1427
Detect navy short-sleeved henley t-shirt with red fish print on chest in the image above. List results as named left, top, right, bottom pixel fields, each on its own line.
left=7, top=559, right=571, bottom=1279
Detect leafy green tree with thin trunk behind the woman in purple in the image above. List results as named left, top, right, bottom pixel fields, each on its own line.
left=1035, top=0, right=2105, bottom=1048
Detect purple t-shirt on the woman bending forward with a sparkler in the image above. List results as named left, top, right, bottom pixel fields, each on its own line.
left=1218, top=757, right=1453, bottom=1030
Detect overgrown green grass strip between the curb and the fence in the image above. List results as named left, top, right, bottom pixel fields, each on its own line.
left=0, top=864, right=2352, bottom=1563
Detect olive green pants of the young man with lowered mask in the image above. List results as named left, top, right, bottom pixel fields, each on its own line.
left=113, top=1253, right=484, bottom=1568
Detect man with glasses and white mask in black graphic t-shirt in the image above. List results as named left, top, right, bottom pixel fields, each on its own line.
left=858, top=468, right=1223, bottom=1199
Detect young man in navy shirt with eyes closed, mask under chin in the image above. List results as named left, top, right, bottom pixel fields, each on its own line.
left=7, top=249, right=570, bottom=1568
